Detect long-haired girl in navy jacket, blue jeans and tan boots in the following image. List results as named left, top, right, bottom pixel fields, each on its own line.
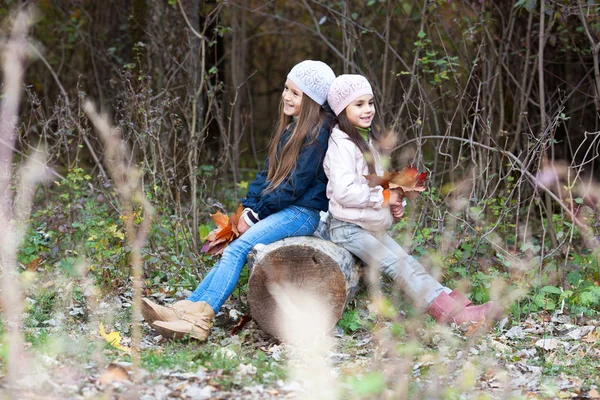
left=142, top=60, right=335, bottom=341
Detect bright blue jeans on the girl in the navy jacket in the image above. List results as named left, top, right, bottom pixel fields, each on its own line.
left=188, top=206, right=319, bottom=314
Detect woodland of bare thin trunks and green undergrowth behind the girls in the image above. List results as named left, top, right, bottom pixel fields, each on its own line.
left=0, top=0, right=600, bottom=393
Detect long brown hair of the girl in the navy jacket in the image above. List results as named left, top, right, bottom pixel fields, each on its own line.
left=264, top=93, right=329, bottom=194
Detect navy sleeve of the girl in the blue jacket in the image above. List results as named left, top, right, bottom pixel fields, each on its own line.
left=252, top=127, right=329, bottom=220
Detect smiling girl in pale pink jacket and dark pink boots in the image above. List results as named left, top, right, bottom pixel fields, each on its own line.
left=323, top=75, right=503, bottom=324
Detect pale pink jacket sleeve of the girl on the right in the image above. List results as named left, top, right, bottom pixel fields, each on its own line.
left=327, top=139, right=384, bottom=209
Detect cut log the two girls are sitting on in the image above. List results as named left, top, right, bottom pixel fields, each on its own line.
left=248, top=236, right=362, bottom=337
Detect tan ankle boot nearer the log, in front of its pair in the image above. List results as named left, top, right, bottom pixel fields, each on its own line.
left=152, top=301, right=215, bottom=342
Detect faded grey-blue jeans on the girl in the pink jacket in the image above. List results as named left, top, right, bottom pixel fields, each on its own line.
left=329, top=216, right=451, bottom=309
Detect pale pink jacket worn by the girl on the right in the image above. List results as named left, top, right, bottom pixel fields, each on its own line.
left=323, top=125, right=394, bottom=232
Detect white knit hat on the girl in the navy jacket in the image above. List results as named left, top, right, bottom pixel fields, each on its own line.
left=288, top=60, right=335, bottom=105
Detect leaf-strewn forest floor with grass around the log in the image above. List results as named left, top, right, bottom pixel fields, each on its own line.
left=0, top=276, right=600, bottom=399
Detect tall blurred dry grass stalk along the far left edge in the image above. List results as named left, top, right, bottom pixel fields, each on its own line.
left=0, top=11, right=45, bottom=388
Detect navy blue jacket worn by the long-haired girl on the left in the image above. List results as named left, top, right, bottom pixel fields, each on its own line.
left=242, top=121, right=331, bottom=220
